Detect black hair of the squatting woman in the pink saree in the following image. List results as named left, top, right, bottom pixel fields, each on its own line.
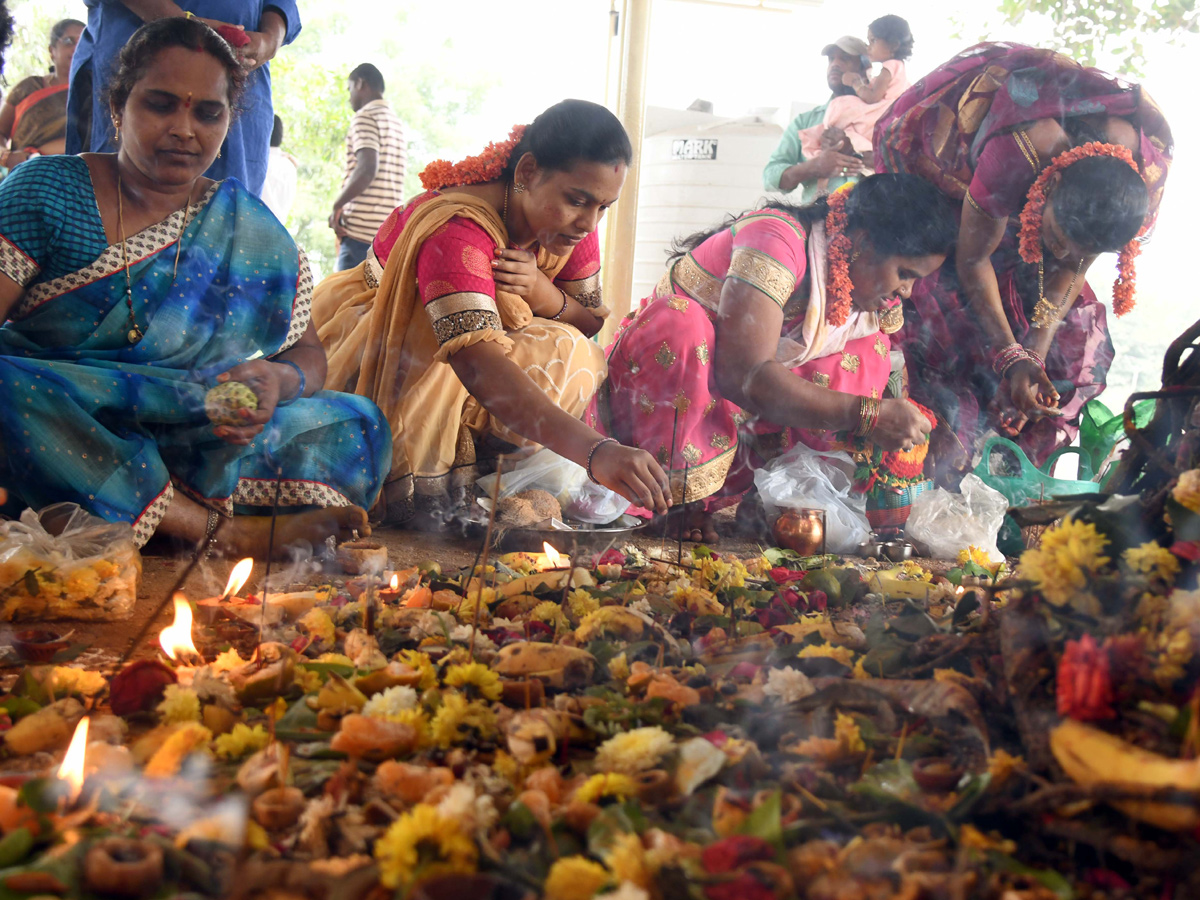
left=668, top=173, right=959, bottom=260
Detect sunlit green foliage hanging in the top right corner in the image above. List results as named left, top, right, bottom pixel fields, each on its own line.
left=1000, top=0, right=1200, bottom=76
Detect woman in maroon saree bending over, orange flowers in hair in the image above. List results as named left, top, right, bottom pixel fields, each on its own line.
left=875, top=43, right=1172, bottom=463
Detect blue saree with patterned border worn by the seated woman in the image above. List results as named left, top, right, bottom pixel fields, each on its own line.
left=0, top=156, right=391, bottom=544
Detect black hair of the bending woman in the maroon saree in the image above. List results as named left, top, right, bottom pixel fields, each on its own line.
left=1050, top=156, right=1150, bottom=253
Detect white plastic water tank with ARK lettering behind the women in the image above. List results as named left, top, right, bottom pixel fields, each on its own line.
left=632, top=107, right=782, bottom=308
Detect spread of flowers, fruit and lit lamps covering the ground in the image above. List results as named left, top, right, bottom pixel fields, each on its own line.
left=0, top=472, right=1200, bottom=900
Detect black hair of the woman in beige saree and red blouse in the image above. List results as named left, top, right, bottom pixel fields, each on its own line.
left=503, top=100, right=634, bottom=179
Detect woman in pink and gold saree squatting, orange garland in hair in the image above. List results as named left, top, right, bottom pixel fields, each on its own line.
left=587, top=175, right=955, bottom=541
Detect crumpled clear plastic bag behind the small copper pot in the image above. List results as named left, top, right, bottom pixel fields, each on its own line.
left=754, top=444, right=871, bottom=553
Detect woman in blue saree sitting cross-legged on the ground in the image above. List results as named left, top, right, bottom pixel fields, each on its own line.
left=0, top=18, right=391, bottom=556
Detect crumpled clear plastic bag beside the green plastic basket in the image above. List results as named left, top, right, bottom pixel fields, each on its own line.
left=906, top=473, right=1008, bottom=563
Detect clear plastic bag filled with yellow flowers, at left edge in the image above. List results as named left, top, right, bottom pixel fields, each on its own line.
left=0, top=503, right=142, bottom=622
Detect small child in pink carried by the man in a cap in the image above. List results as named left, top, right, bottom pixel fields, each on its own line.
left=800, top=16, right=913, bottom=158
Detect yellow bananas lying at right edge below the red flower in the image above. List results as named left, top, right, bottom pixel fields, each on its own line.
left=1050, top=719, right=1200, bottom=832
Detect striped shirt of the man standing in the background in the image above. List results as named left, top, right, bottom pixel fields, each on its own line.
left=342, top=100, right=407, bottom=242
